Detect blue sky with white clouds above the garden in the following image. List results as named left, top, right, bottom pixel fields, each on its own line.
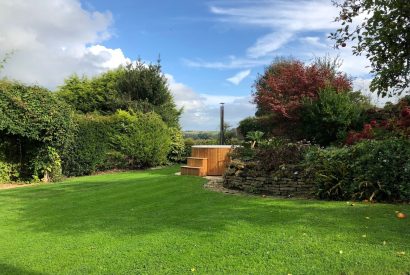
left=0, top=0, right=390, bottom=130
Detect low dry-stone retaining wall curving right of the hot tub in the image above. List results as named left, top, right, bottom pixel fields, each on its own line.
left=223, top=163, right=315, bottom=197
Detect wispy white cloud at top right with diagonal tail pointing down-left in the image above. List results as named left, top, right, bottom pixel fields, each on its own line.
left=210, top=0, right=337, bottom=58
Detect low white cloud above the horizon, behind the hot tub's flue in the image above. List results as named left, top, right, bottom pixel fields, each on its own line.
left=166, top=74, right=256, bottom=130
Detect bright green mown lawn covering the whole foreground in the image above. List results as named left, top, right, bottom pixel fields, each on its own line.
left=0, top=167, right=410, bottom=275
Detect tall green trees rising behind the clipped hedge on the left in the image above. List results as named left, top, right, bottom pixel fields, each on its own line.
left=57, top=60, right=182, bottom=127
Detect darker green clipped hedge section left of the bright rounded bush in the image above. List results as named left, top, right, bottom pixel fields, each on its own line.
left=62, top=114, right=113, bottom=176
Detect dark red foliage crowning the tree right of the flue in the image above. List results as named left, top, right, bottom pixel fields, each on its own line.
left=253, top=61, right=352, bottom=118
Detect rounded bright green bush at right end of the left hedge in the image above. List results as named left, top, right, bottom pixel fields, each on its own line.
left=111, top=110, right=171, bottom=168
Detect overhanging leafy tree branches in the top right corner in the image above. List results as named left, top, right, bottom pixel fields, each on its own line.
left=329, top=0, right=410, bottom=97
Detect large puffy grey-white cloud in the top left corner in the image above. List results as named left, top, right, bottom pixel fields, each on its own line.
left=0, top=0, right=130, bottom=89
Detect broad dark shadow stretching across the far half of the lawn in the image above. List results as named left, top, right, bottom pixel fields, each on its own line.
left=0, top=169, right=410, bottom=241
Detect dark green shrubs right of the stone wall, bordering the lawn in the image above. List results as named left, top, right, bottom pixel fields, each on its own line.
left=307, top=138, right=410, bottom=201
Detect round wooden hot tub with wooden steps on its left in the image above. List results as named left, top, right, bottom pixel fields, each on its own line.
left=181, top=145, right=232, bottom=176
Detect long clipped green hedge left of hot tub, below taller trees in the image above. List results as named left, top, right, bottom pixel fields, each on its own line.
left=63, top=110, right=175, bottom=176
